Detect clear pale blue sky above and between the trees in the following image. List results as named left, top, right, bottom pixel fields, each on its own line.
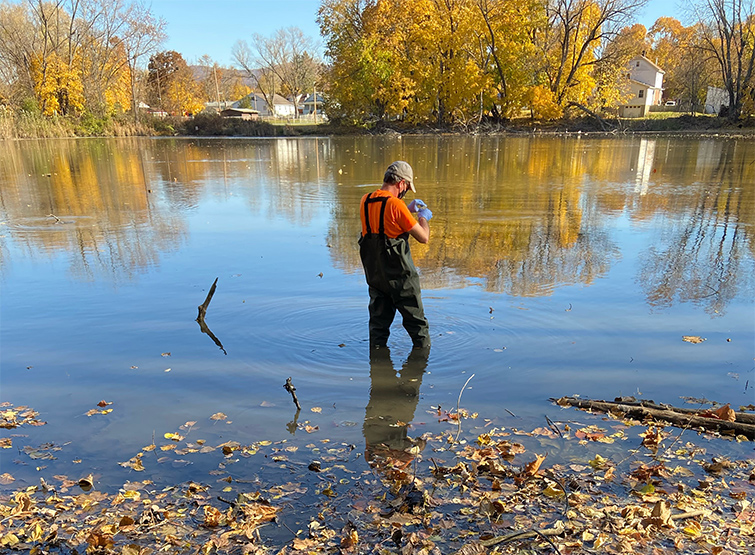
left=151, top=0, right=683, bottom=65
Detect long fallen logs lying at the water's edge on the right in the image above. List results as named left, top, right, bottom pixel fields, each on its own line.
left=551, top=397, right=755, bottom=440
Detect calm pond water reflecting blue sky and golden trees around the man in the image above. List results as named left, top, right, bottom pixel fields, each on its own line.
left=0, top=137, right=755, bottom=487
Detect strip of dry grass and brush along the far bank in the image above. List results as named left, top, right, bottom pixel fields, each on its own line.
left=0, top=112, right=755, bottom=140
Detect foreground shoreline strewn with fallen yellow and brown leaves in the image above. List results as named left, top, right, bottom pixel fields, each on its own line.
left=0, top=403, right=755, bottom=555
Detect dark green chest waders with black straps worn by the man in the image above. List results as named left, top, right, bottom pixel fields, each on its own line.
left=359, top=194, right=430, bottom=347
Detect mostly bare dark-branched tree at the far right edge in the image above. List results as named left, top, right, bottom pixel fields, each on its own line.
left=693, top=0, right=755, bottom=120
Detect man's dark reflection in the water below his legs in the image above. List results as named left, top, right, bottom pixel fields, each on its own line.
left=363, top=347, right=430, bottom=470
